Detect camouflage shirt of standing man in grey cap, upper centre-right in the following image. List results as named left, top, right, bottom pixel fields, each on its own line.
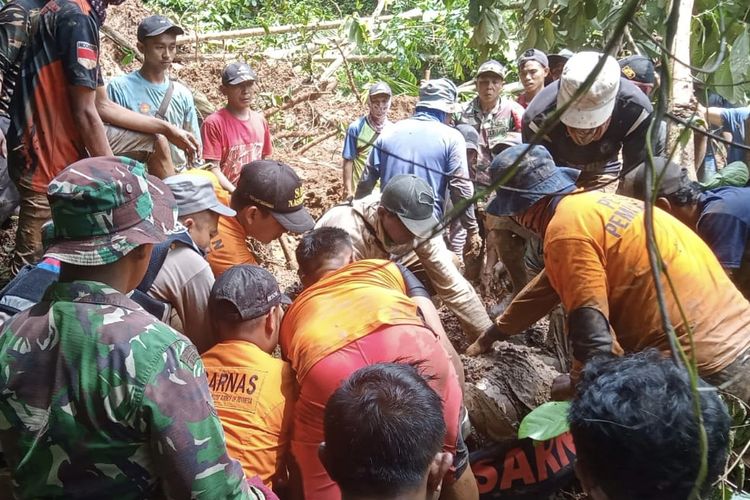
left=458, top=97, right=523, bottom=184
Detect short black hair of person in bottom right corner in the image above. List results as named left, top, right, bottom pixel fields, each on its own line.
left=569, top=349, right=730, bottom=500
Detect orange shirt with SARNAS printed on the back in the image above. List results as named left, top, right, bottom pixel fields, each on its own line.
left=202, top=340, right=295, bottom=487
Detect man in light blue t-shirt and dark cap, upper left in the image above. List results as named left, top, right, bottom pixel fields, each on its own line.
left=107, top=16, right=200, bottom=171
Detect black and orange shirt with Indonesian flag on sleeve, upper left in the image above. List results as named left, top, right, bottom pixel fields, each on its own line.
left=8, top=0, right=100, bottom=193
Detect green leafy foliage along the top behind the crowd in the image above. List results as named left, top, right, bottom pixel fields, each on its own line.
left=148, top=0, right=750, bottom=103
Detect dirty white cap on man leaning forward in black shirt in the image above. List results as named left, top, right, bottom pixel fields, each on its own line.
left=557, top=52, right=620, bottom=129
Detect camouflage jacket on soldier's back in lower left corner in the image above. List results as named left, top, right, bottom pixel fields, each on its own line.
left=0, top=281, right=263, bottom=499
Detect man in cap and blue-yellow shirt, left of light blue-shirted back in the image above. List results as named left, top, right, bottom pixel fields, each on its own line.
left=341, top=82, right=392, bottom=200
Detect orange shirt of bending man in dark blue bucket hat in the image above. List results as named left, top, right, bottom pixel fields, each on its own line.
left=544, top=192, right=750, bottom=376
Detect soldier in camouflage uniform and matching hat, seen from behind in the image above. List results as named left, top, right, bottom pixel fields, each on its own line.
left=0, top=157, right=264, bottom=499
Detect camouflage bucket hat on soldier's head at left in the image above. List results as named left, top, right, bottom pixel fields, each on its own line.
left=44, top=157, right=177, bottom=266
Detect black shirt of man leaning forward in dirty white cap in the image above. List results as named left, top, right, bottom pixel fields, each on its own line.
left=522, top=78, right=660, bottom=177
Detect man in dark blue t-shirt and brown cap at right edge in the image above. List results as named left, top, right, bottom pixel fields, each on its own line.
left=634, top=158, right=750, bottom=299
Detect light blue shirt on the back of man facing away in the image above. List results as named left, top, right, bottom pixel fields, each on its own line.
left=365, top=113, right=468, bottom=219
